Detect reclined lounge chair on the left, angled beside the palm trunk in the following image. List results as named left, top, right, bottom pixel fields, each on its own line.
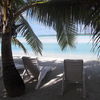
left=22, top=57, right=51, bottom=89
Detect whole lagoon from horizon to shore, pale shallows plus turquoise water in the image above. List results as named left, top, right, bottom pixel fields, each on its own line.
left=12, top=36, right=94, bottom=55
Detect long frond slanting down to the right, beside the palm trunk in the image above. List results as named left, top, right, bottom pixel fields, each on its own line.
left=17, top=16, right=42, bottom=54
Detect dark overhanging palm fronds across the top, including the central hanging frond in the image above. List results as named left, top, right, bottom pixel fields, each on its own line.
left=0, top=0, right=100, bottom=54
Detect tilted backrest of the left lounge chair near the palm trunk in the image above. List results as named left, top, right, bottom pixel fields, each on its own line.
left=22, top=57, right=39, bottom=79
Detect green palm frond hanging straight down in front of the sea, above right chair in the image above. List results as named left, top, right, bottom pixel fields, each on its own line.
left=56, top=21, right=76, bottom=50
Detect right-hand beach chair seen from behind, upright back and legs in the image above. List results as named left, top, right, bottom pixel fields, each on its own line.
left=62, top=59, right=85, bottom=97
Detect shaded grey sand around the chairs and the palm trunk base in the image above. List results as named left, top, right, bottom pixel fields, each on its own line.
left=0, top=58, right=100, bottom=100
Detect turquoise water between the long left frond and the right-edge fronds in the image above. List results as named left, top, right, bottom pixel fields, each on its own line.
left=43, top=43, right=93, bottom=54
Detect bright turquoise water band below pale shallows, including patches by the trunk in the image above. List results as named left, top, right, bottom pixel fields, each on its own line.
left=12, top=43, right=93, bottom=54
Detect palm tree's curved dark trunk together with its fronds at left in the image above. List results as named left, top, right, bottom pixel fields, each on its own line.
left=0, top=0, right=42, bottom=96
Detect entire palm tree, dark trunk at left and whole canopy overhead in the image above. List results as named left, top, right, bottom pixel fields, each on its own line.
left=0, top=0, right=100, bottom=96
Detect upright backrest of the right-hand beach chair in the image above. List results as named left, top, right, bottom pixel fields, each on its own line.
left=64, top=59, right=83, bottom=82
